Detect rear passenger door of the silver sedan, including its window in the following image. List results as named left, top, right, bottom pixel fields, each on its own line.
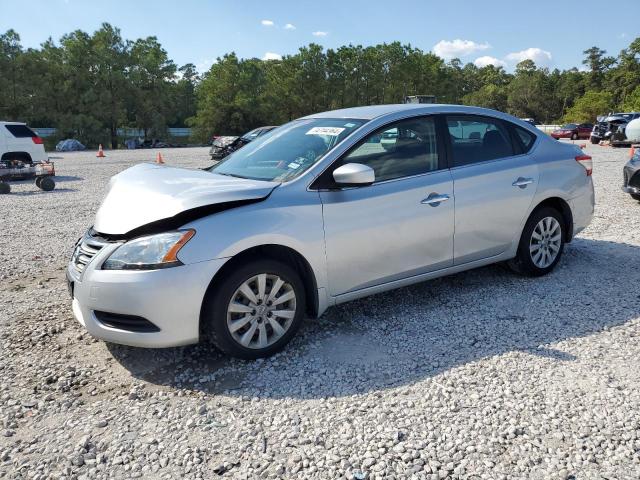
left=446, top=115, right=538, bottom=265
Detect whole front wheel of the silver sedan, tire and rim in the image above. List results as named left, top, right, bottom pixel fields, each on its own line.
left=201, top=259, right=305, bottom=360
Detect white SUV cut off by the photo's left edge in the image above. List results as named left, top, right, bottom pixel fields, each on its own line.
left=0, top=122, right=48, bottom=164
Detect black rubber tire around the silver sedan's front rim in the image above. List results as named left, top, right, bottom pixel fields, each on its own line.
left=200, top=259, right=306, bottom=360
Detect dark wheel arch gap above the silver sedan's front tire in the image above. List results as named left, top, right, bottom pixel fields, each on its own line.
left=200, top=244, right=320, bottom=330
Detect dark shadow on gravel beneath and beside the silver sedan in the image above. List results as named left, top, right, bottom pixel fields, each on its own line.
left=108, top=238, right=640, bottom=398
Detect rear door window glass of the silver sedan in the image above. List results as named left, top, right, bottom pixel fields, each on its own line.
left=447, top=115, right=514, bottom=167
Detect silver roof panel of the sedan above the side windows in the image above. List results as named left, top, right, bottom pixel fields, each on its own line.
left=302, top=103, right=522, bottom=123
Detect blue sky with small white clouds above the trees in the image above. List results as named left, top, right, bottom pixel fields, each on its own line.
left=0, top=0, right=640, bottom=72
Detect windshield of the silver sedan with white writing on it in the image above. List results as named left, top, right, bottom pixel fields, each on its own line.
left=210, top=118, right=365, bottom=182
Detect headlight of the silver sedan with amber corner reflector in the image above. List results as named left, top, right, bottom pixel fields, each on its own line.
left=102, top=230, right=196, bottom=270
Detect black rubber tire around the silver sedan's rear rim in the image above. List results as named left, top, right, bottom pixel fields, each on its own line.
left=509, top=207, right=567, bottom=277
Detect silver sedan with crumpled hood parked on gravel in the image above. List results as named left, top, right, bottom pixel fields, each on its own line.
left=67, top=104, right=594, bottom=358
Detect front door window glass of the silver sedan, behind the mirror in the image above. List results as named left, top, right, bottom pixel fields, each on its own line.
left=340, top=118, right=438, bottom=182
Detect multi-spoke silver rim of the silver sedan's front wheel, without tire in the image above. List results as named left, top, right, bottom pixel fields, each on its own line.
left=227, top=273, right=296, bottom=349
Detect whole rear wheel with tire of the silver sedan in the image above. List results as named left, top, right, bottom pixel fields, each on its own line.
left=509, top=208, right=566, bottom=277
